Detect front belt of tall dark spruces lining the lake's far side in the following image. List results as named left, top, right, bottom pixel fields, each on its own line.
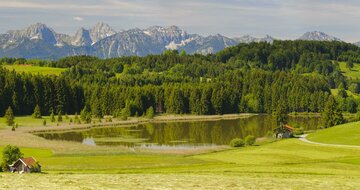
left=0, top=69, right=330, bottom=117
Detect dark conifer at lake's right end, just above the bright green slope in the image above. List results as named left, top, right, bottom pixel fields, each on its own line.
left=322, top=96, right=344, bottom=128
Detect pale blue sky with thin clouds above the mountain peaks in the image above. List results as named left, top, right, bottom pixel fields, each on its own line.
left=0, top=0, right=360, bottom=42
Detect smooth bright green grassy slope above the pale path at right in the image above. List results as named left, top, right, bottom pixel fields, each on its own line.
left=307, top=122, right=360, bottom=146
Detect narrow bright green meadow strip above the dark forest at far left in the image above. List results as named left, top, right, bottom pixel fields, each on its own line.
left=3, top=65, right=65, bottom=76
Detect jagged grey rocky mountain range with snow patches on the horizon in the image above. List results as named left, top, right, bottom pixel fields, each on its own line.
left=0, top=22, right=360, bottom=59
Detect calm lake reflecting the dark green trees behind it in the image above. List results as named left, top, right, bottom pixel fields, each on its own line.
left=36, top=115, right=321, bottom=148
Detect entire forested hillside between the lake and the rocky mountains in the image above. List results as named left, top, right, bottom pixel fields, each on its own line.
left=0, top=41, right=360, bottom=117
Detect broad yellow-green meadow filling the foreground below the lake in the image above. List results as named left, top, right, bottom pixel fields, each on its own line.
left=0, top=118, right=360, bottom=189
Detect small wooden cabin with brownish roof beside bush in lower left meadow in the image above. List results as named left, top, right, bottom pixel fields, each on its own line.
left=9, top=157, right=41, bottom=173
